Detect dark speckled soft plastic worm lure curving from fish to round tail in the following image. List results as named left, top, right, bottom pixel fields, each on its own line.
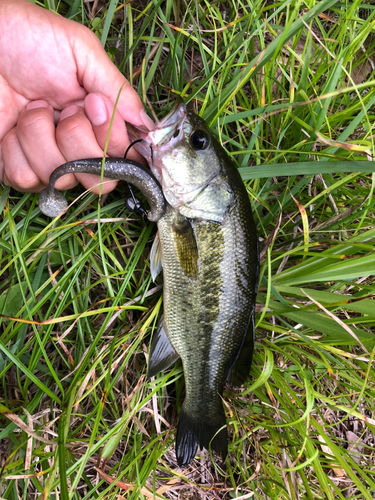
left=39, top=158, right=166, bottom=222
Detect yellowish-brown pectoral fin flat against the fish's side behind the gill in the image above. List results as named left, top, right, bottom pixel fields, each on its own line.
left=172, top=219, right=198, bottom=278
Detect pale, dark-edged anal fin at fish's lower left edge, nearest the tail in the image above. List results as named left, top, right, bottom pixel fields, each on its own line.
left=147, top=319, right=180, bottom=378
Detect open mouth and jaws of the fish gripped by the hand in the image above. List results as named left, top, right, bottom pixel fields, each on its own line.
left=126, top=98, right=187, bottom=163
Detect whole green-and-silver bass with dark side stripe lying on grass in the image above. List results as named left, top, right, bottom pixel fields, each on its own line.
left=127, top=101, right=259, bottom=467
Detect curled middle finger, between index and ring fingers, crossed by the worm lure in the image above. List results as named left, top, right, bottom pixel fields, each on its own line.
left=56, top=104, right=117, bottom=194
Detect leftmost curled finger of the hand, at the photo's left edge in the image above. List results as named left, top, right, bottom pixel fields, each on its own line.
left=0, top=128, right=45, bottom=193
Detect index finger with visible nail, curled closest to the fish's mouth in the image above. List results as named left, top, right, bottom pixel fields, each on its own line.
left=85, top=93, right=144, bottom=162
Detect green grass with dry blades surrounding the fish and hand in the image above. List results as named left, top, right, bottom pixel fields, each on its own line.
left=0, top=0, right=375, bottom=500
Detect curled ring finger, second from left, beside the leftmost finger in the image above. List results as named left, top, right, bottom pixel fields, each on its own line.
left=16, top=100, right=77, bottom=189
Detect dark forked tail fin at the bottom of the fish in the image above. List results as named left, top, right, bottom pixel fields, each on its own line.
left=176, top=403, right=228, bottom=467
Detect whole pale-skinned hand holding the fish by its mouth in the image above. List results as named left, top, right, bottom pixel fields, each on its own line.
left=0, top=0, right=153, bottom=193
